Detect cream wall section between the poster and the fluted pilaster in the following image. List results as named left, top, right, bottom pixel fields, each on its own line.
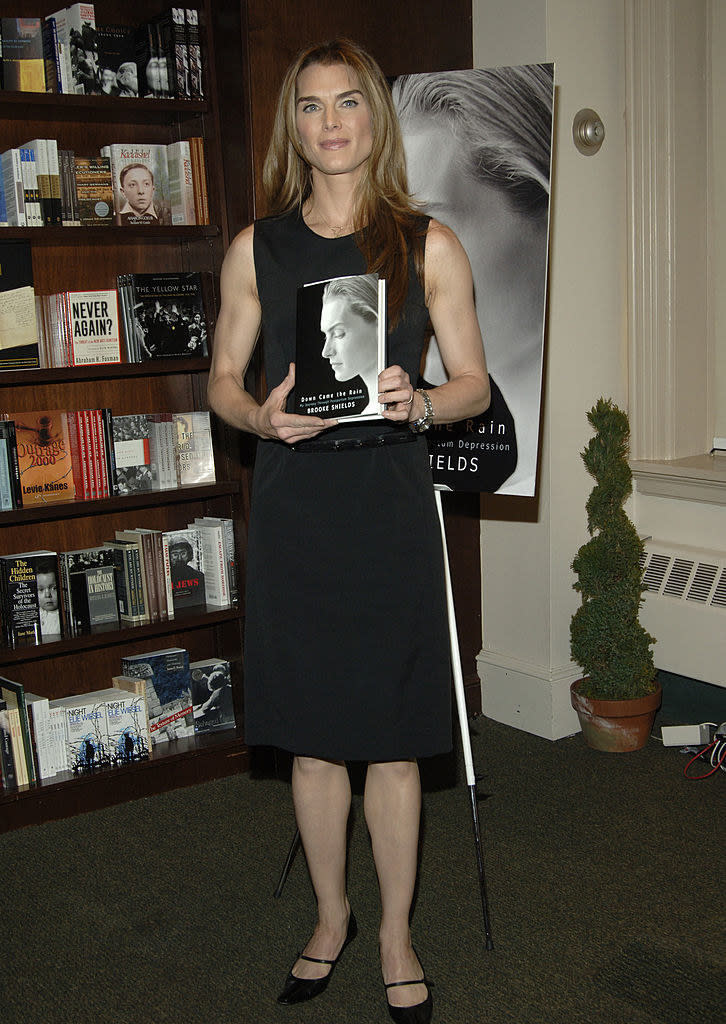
left=474, top=0, right=627, bottom=738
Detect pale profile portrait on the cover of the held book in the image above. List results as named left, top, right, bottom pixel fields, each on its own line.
left=321, top=273, right=379, bottom=416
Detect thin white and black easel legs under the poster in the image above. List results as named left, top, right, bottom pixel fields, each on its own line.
left=274, top=485, right=494, bottom=949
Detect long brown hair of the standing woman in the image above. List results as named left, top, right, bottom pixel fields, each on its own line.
left=262, top=39, right=425, bottom=325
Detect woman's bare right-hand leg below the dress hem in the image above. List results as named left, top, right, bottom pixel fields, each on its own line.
left=364, top=761, right=428, bottom=1007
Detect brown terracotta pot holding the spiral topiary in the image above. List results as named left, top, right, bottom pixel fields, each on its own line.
left=569, top=679, right=663, bottom=754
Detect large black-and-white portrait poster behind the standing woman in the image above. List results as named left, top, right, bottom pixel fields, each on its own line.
left=392, top=63, right=554, bottom=496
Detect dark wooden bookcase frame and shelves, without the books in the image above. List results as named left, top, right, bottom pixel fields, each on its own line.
left=0, top=0, right=248, bottom=831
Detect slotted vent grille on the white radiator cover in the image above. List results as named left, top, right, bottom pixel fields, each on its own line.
left=641, top=541, right=726, bottom=610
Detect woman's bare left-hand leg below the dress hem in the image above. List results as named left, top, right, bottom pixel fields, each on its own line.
left=293, top=757, right=350, bottom=978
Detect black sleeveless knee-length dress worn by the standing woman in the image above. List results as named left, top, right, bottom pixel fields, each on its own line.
left=244, top=212, right=452, bottom=761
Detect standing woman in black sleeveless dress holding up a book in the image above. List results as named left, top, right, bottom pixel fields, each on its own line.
left=209, top=40, right=488, bottom=1024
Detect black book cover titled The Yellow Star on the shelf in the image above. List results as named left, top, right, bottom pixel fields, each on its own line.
left=128, top=270, right=208, bottom=360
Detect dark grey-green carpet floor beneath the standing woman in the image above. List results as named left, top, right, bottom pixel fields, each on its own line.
left=0, top=718, right=726, bottom=1024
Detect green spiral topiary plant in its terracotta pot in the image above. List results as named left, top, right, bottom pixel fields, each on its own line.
left=570, top=398, right=660, bottom=751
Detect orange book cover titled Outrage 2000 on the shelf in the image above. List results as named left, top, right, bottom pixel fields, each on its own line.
left=2, top=409, right=76, bottom=506
